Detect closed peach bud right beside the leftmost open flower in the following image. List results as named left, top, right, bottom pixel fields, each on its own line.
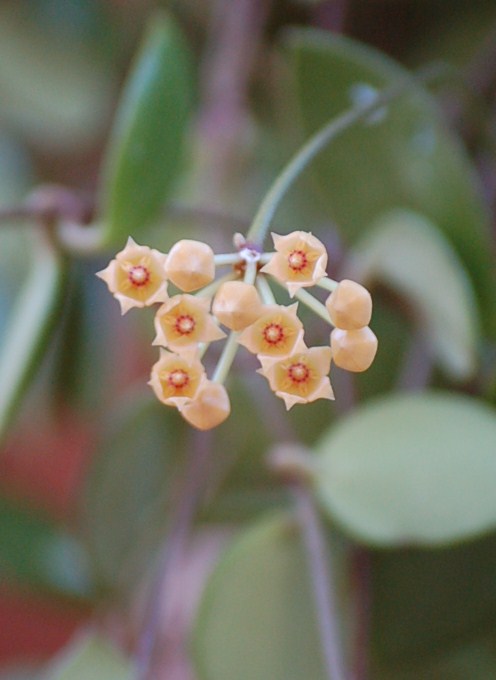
left=165, top=239, right=215, bottom=293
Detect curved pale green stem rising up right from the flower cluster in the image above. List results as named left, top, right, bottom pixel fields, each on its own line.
left=246, top=65, right=446, bottom=245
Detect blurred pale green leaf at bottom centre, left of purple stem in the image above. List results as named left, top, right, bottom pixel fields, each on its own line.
left=193, top=516, right=327, bottom=680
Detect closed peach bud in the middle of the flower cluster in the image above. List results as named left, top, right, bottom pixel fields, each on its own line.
left=212, top=281, right=263, bottom=331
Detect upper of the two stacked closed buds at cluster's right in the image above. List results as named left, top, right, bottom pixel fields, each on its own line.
left=326, top=279, right=372, bottom=331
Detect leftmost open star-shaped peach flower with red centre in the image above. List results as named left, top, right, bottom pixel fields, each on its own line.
left=97, top=237, right=168, bottom=314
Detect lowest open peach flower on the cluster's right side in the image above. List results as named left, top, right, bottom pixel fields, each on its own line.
left=259, top=347, right=334, bottom=411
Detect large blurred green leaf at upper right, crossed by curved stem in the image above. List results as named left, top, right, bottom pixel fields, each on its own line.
left=285, top=29, right=496, bottom=335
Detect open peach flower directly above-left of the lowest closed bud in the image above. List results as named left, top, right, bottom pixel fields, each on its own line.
left=148, top=349, right=206, bottom=410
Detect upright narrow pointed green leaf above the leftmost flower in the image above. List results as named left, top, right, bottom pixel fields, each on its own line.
left=101, top=14, right=193, bottom=245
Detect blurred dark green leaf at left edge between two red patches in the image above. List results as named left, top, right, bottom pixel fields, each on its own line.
left=0, top=498, right=91, bottom=599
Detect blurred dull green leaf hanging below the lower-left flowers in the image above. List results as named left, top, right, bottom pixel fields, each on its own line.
left=82, top=391, right=184, bottom=588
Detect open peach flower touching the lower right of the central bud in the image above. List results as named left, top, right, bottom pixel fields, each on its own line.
left=238, top=303, right=303, bottom=358
